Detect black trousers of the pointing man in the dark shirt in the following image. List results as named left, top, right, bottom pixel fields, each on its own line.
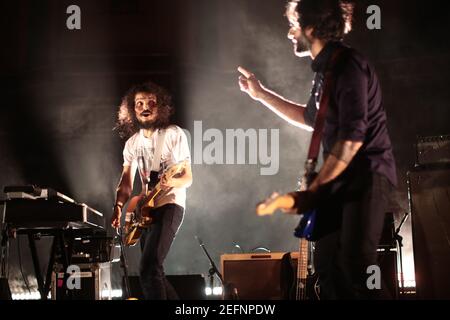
left=314, top=170, right=394, bottom=299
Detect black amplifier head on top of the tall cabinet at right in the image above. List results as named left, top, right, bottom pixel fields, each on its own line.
left=416, top=135, right=450, bottom=166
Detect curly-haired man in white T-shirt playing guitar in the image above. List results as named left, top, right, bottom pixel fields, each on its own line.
left=111, top=82, right=192, bottom=300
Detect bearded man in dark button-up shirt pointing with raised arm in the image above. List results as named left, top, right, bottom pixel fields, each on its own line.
left=239, top=0, right=397, bottom=299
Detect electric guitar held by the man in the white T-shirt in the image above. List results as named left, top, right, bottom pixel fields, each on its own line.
left=124, top=160, right=188, bottom=246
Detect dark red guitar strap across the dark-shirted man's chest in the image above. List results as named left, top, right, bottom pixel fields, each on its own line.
left=308, top=48, right=344, bottom=165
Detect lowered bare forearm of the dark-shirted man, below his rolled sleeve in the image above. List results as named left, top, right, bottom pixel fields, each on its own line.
left=309, top=140, right=363, bottom=192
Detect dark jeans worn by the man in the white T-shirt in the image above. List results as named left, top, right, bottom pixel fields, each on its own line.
left=139, top=204, right=184, bottom=300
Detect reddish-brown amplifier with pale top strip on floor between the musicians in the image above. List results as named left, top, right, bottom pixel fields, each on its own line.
left=220, top=253, right=298, bottom=300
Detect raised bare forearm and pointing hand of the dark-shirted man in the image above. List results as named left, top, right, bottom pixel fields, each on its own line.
left=238, top=67, right=312, bottom=131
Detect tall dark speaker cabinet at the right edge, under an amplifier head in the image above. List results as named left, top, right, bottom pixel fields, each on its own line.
left=408, top=167, right=450, bottom=299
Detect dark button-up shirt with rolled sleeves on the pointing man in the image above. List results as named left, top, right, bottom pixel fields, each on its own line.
left=305, top=42, right=397, bottom=185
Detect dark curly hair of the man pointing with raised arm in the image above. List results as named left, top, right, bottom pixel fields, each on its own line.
left=290, top=0, right=354, bottom=41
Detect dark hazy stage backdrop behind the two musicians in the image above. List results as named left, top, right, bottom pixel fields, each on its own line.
left=0, top=0, right=450, bottom=291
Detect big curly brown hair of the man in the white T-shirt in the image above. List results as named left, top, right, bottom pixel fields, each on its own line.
left=114, top=81, right=174, bottom=139
